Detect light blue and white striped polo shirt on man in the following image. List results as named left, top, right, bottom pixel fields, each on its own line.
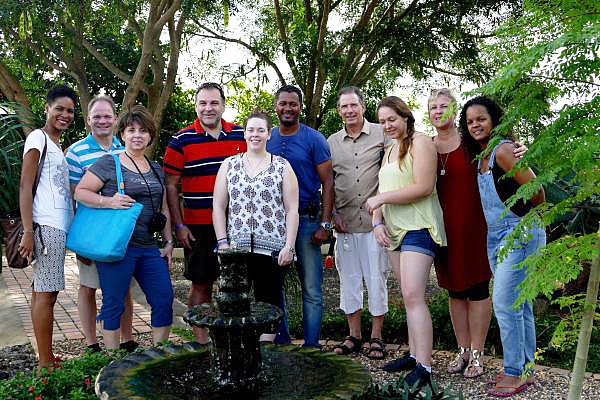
left=65, top=133, right=125, bottom=185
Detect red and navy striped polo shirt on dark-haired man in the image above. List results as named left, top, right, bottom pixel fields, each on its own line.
left=164, top=119, right=246, bottom=225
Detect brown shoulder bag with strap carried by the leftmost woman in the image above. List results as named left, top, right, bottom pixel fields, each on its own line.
left=2, top=133, right=48, bottom=269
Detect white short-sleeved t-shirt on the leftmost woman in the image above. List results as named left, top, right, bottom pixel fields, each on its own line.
left=23, top=129, right=73, bottom=232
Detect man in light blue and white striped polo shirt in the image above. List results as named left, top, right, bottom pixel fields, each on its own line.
left=66, top=95, right=137, bottom=352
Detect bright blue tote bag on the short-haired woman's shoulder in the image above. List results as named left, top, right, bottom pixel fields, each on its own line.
left=66, top=154, right=144, bottom=262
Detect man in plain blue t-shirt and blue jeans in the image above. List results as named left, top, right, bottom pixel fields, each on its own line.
left=267, top=85, right=333, bottom=348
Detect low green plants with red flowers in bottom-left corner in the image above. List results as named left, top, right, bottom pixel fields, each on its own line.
left=0, top=351, right=126, bottom=400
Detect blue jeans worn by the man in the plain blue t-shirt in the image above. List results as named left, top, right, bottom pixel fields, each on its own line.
left=275, top=215, right=323, bottom=348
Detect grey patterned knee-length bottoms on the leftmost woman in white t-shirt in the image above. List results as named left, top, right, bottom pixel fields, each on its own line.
left=31, top=225, right=67, bottom=292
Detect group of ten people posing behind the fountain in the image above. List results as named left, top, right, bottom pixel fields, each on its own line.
left=20, top=83, right=545, bottom=397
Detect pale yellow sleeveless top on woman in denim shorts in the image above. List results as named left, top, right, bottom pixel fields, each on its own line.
left=379, top=144, right=446, bottom=250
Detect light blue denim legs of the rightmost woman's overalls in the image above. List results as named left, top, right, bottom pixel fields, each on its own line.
left=488, top=217, right=546, bottom=376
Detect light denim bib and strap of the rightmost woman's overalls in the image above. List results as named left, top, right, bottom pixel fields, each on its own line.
left=477, top=140, right=521, bottom=228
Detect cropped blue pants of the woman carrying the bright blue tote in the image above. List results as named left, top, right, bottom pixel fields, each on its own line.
left=96, top=246, right=173, bottom=331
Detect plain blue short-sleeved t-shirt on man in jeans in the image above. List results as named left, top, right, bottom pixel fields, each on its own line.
left=267, top=124, right=331, bottom=209
